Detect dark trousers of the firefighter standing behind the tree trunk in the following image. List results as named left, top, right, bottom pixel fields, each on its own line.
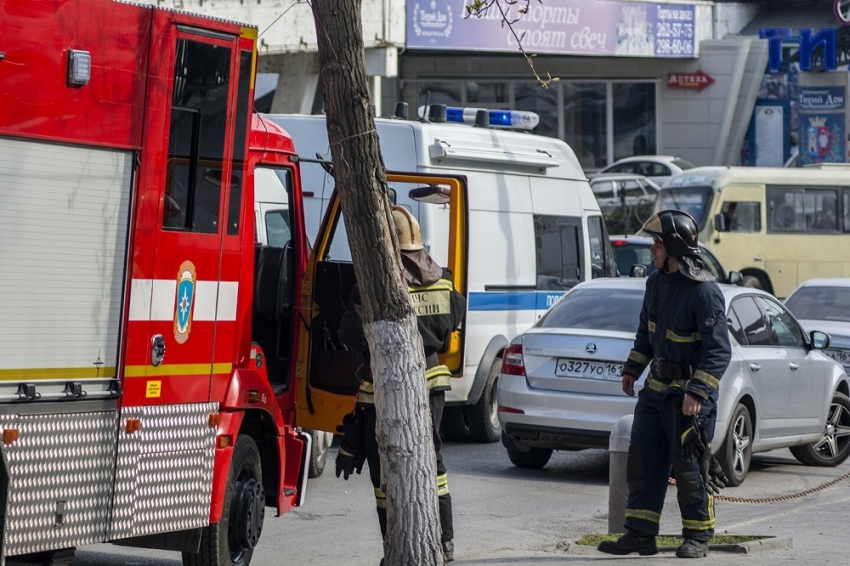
left=364, top=391, right=454, bottom=542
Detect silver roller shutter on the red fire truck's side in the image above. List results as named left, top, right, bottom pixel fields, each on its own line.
left=0, top=138, right=133, bottom=402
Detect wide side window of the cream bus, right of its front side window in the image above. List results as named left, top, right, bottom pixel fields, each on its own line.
left=767, top=187, right=838, bottom=232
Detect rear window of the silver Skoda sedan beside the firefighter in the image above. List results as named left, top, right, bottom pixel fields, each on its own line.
left=537, top=289, right=643, bottom=332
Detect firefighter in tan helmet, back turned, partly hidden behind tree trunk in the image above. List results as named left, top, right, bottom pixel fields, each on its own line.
left=336, top=206, right=466, bottom=563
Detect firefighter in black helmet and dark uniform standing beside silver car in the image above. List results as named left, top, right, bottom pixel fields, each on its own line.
left=598, top=210, right=731, bottom=558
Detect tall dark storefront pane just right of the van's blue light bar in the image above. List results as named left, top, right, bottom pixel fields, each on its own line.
left=563, top=83, right=608, bottom=170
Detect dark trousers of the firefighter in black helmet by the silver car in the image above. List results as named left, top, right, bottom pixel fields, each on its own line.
left=625, top=389, right=717, bottom=541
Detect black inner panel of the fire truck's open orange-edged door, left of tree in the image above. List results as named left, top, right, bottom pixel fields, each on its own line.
left=310, top=261, right=360, bottom=395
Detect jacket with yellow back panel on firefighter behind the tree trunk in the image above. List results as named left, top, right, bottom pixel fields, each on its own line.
left=340, top=264, right=466, bottom=405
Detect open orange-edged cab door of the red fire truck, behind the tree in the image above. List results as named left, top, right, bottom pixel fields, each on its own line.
left=296, top=173, right=468, bottom=432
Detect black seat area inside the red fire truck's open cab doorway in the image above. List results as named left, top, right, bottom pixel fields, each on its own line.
left=251, top=242, right=295, bottom=395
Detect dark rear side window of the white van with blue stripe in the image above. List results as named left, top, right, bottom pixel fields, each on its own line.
left=534, top=214, right=583, bottom=291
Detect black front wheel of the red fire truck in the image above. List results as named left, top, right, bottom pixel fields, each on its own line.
left=183, top=434, right=266, bottom=566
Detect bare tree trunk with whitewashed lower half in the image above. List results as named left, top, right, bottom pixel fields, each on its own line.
left=313, top=0, right=443, bottom=566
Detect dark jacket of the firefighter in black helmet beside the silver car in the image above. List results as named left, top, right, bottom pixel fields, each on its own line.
left=623, top=271, right=731, bottom=401
